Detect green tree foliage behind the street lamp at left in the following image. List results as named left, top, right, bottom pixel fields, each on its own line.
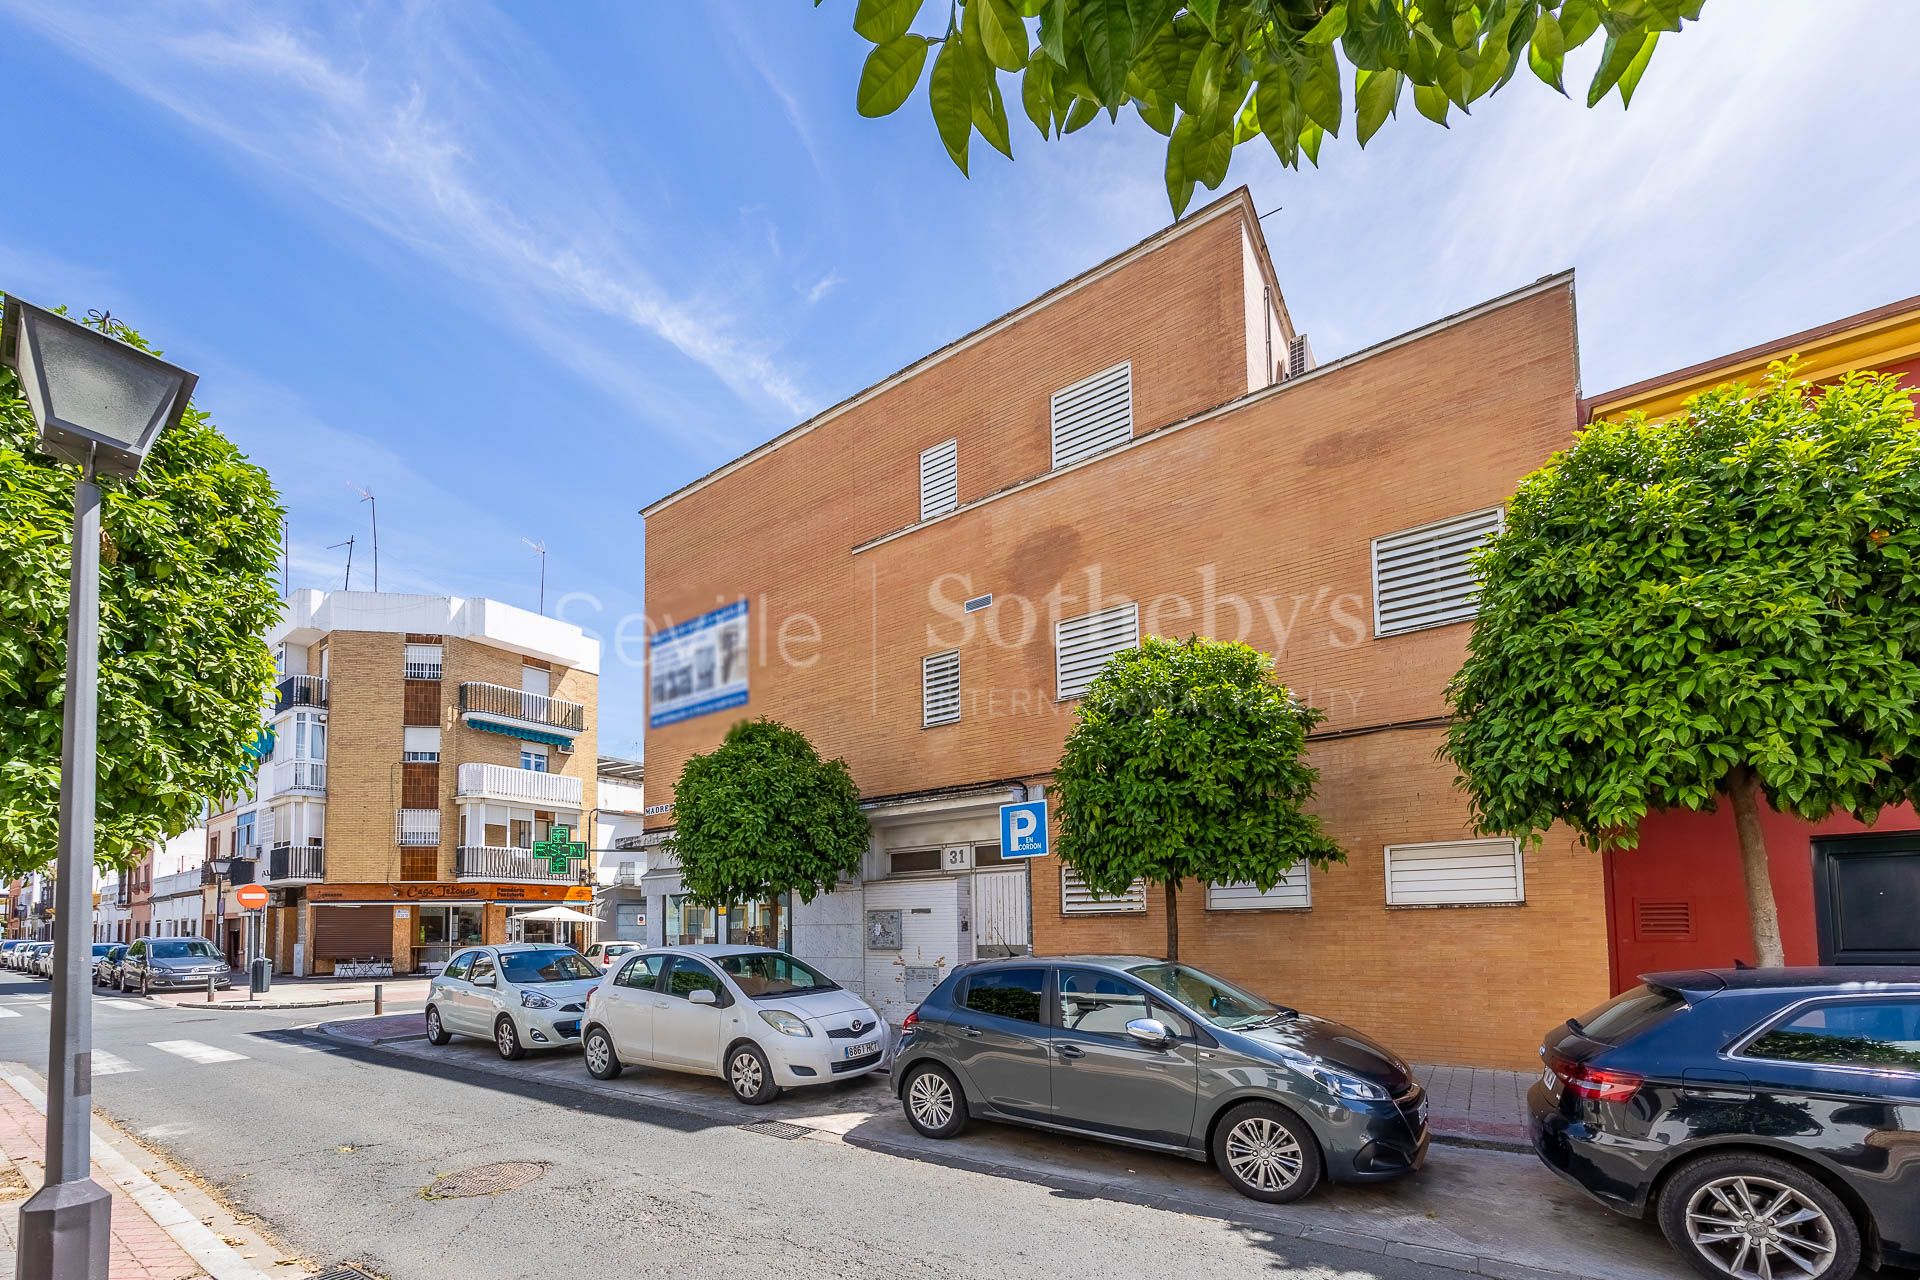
left=0, top=301, right=280, bottom=879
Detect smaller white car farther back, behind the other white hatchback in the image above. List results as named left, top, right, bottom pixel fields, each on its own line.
left=426, top=942, right=601, bottom=1059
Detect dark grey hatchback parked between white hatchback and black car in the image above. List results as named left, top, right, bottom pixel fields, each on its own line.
left=891, top=956, right=1427, bottom=1203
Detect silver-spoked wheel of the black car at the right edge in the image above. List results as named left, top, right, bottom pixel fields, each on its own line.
left=1659, top=1155, right=1860, bottom=1280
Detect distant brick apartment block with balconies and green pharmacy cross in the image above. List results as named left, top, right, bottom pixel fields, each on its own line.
left=235, top=591, right=599, bottom=975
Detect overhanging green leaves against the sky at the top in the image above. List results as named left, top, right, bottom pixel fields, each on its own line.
left=833, top=0, right=1705, bottom=215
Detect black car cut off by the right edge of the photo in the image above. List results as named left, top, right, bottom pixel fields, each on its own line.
left=1528, top=967, right=1920, bottom=1280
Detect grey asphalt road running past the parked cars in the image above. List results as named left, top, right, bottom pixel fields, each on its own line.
left=0, top=975, right=1666, bottom=1280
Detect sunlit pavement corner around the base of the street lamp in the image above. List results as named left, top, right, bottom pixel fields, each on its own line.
left=0, top=1063, right=305, bottom=1280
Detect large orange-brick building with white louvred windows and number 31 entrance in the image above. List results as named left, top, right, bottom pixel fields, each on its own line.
left=643, top=190, right=1609, bottom=1065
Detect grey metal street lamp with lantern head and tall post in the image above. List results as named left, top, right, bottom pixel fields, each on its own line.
left=0, top=297, right=196, bottom=1280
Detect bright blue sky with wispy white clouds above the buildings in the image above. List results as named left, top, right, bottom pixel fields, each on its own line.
left=0, top=0, right=1920, bottom=754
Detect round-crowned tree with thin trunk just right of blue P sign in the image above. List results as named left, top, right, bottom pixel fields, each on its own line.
left=1054, top=637, right=1344, bottom=960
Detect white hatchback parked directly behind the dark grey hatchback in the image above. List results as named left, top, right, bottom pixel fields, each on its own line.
left=582, top=944, right=887, bottom=1103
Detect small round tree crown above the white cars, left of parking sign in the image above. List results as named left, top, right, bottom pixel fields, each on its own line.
left=672, top=720, right=868, bottom=908
